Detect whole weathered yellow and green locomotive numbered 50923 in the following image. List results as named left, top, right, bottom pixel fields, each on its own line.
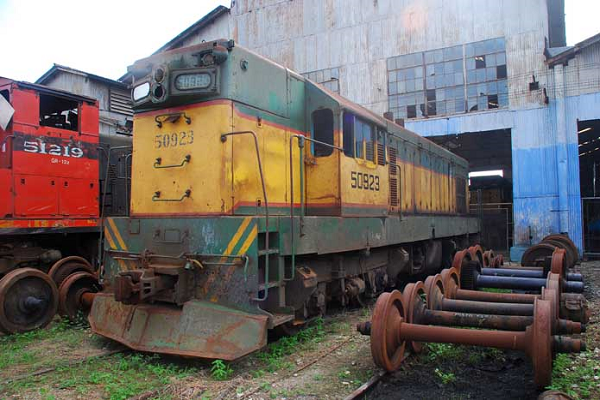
left=89, top=40, right=478, bottom=360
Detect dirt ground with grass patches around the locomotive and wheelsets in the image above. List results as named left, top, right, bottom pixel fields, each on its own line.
left=0, top=262, right=600, bottom=400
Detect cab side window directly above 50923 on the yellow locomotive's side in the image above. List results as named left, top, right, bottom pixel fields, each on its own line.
left=344, top=113, right=376, bottom=162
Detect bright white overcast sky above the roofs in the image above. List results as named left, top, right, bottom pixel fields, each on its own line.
left=0, top=0, right=600, bottom=82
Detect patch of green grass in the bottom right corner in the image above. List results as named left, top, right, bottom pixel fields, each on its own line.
left=548, top=351, right=600, bottom=399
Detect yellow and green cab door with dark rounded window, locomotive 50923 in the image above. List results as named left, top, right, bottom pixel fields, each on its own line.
left=304, top=81, right=341, bottom=215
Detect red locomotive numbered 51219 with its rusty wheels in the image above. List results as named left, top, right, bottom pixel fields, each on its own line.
left=0, top=77, right=127, bottom=333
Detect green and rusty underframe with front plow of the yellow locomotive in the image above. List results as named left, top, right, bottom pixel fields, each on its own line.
left=90, top=215, right=479, bottom=360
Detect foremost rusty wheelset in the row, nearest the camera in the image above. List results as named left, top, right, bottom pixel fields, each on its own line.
left=358, top=285, right=585, bottom=387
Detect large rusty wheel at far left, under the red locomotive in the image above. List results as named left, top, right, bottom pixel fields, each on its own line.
left=0, top=268, right=58, bottom=334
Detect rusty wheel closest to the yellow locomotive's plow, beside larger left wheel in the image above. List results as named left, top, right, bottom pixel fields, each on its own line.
left=58, top=272, right=102, bottom=322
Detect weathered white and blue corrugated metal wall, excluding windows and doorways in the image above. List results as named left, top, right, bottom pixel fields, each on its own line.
left=182, top=0, right=600, bottom=255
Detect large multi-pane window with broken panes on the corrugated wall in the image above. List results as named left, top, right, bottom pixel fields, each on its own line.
left=387, top=38, right=508, bottom=118
